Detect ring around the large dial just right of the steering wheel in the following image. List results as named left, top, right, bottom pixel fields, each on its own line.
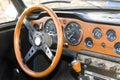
left=64, top=21, right=83, bottom=46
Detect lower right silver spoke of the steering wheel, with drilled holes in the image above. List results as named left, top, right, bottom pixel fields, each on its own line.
left=42, top=43, right=54, bottom=61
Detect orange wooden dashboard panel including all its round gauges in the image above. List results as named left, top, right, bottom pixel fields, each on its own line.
left=33, top=17, right=120, bottom=57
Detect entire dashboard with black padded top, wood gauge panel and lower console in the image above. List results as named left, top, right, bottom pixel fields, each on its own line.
left=31, top=11, right=120, bottom=80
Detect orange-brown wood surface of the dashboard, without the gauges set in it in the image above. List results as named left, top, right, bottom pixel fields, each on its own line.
left=31, top=17, right=120, bottom=57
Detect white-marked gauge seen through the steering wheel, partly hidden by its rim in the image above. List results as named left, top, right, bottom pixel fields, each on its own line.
left=44, top=19, right=57, bottom=34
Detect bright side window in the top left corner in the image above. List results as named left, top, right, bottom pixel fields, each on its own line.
left=0, top=0, right=17, bottom=23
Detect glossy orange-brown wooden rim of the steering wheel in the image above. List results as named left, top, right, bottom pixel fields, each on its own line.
left=14, top=5, right=63, bottom=78
